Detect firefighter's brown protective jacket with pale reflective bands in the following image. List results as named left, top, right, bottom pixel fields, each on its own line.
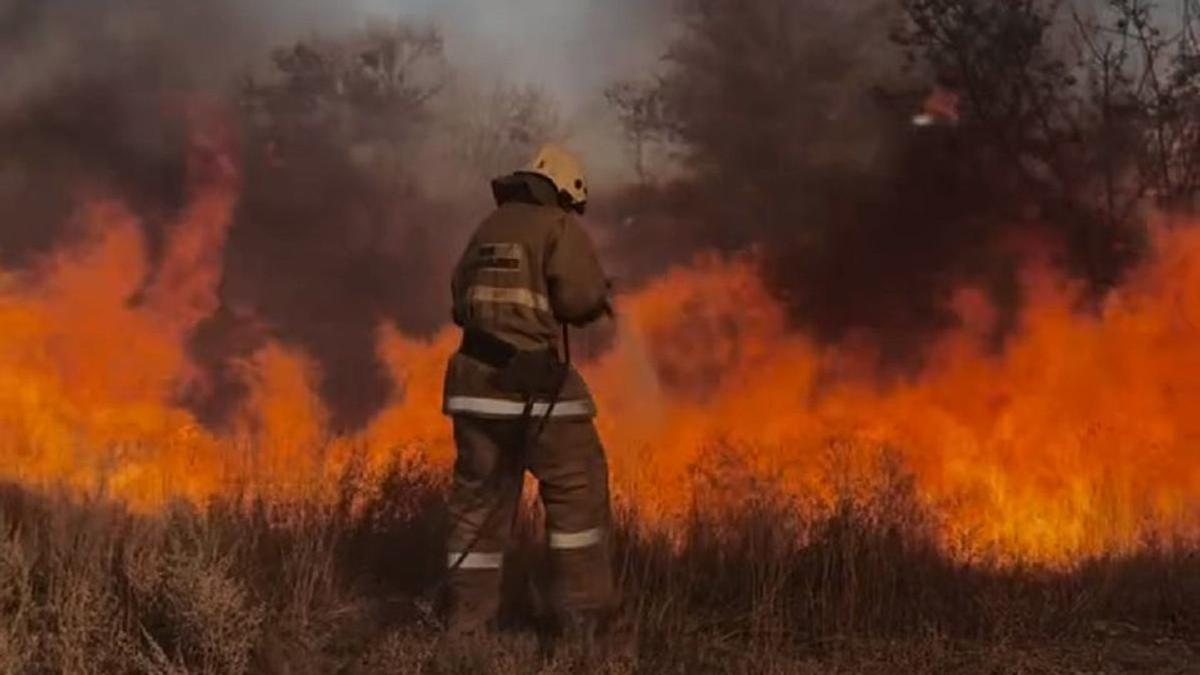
left=443, top=173, right=608, bottom=419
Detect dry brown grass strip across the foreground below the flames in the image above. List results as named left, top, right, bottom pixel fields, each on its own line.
left=0, top=451, right=1200, bottom=675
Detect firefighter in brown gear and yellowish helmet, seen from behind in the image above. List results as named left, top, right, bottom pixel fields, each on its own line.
left=444, top=145, right=614, bottom=634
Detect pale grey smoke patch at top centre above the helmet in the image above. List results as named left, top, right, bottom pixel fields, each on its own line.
left=356, top=0, right=677, bottom=182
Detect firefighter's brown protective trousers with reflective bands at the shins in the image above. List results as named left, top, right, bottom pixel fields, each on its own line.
left=446, top=416, right=614, bottom=632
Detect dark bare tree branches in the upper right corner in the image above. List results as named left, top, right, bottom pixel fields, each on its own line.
left=899, top=0, right=1200, bottom=285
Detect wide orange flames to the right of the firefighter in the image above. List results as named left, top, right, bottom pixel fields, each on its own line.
left=594, top=239, right=1200, bottom=562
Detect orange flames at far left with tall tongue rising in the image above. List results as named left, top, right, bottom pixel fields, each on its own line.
left=0, top=106, right=343, bottom=509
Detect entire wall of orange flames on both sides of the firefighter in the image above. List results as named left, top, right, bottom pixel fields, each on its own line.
left=0, top=114, right=1200, bottom=563
